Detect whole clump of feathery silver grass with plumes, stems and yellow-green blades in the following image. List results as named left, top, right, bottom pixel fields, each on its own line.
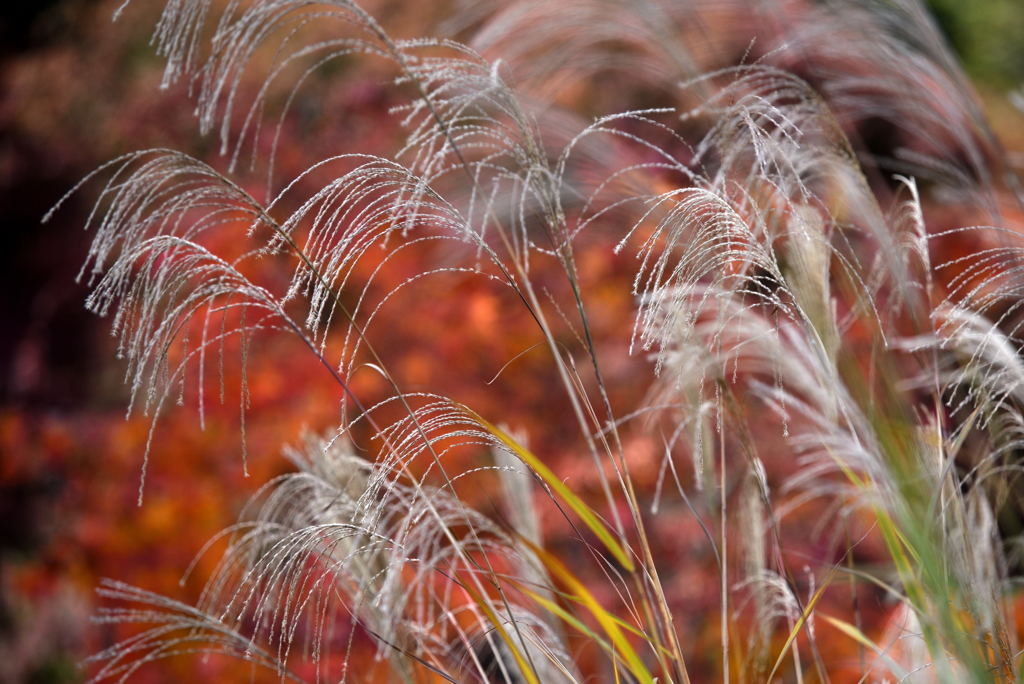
left=49, top=0, right=1024, bottom=684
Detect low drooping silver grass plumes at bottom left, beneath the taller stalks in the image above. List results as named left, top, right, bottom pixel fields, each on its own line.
left=95, top=436, right=574, bottom=683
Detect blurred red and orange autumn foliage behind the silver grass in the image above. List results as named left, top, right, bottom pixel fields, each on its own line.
left=6, top=0, right=1024, bottom=683
